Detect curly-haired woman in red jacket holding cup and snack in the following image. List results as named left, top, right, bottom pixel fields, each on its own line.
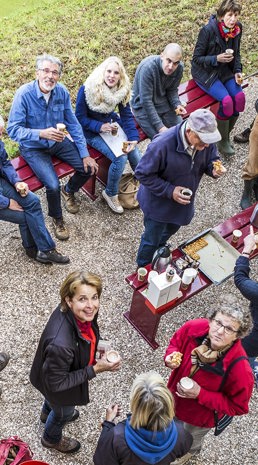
left=165, top=295, right=254, bottom=465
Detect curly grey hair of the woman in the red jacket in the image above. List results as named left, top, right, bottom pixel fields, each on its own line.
left=206, top=294, right=253, bottom=339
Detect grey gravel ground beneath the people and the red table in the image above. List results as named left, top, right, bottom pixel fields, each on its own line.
left=0, top=79, right=258, bottom=465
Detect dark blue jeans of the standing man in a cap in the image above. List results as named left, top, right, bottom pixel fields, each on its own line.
left=136, top=217, right=180, bottom=266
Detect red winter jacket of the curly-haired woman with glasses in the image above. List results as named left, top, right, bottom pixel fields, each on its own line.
left=165, top=318, right=254, bottom=428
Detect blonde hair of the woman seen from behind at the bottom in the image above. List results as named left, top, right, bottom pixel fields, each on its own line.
left=130, top=371, right=175, bottom=431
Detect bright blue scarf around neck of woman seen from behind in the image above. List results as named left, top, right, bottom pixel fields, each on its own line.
left=125, top=415, right=178, bottom=465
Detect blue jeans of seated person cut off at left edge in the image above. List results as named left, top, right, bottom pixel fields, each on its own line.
left=0, top=177, right=55, bottom=252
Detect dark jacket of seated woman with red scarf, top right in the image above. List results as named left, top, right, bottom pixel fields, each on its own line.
left=191, top=15, right=242, bottom=89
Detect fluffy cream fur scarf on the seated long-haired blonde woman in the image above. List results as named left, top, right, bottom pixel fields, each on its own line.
left=84, top=76, right=130, bottom=114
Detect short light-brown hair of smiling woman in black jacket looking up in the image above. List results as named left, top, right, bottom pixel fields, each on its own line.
left=60, top=271, right=102, bottom=312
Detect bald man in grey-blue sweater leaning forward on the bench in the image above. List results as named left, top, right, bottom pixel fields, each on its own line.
left=131, top=43, right=186, bottom=139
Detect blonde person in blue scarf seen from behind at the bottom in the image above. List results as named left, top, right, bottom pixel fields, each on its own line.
left=93, top=371, right=192, bottom=465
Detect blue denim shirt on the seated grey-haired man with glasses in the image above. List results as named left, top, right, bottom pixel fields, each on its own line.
left=7, top=80, right=89, bottom=158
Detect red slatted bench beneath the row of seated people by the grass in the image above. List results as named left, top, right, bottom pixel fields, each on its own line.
left=11, top=79, right=248, bottom=196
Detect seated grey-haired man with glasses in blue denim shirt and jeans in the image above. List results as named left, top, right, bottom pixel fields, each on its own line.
left=7, top=54, right=98, bottom=240
